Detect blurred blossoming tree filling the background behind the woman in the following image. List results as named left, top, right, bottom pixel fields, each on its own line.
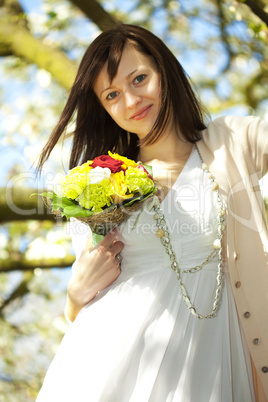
left=0, top=0, right=268, bottom=401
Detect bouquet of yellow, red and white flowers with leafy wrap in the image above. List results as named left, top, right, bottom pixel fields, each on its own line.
left=35, top=151, right=157, bottom=245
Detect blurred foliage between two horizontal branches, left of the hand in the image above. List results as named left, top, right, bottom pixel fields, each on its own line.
left=0, top=220, right=74, bottom=272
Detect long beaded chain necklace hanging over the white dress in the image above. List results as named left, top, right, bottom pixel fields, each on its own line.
left=153, top=144, right=226, bottom=319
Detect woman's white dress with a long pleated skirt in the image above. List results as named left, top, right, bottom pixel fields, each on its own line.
left=37, top=149, right=255, bottom=402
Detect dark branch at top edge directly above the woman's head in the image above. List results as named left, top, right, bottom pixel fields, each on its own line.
left=70, top=0, right=119, bottom=31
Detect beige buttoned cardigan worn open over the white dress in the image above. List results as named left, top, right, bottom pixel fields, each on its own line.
left=197, top=116, right=268, bottom=402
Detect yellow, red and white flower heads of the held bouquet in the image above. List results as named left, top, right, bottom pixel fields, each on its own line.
left=40, top=151, right=156, bottom=219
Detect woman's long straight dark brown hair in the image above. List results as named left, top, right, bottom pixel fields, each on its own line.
left=37, top=24, right=206, bottom=170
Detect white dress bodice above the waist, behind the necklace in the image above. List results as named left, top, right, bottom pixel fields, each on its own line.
left=120, top=148, right=221, bottom=276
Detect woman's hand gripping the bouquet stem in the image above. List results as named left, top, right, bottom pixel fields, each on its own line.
left=67, top=229, right=124, bottom=321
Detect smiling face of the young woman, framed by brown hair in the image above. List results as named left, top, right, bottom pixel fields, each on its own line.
left=94, top=44, right=161, bottom=138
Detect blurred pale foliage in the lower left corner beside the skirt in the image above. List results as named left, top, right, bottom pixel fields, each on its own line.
left=0, top=271, right=67, bottom=402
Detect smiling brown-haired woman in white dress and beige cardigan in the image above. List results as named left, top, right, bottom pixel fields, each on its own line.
left=37, top=25, right=268, bottom=402
